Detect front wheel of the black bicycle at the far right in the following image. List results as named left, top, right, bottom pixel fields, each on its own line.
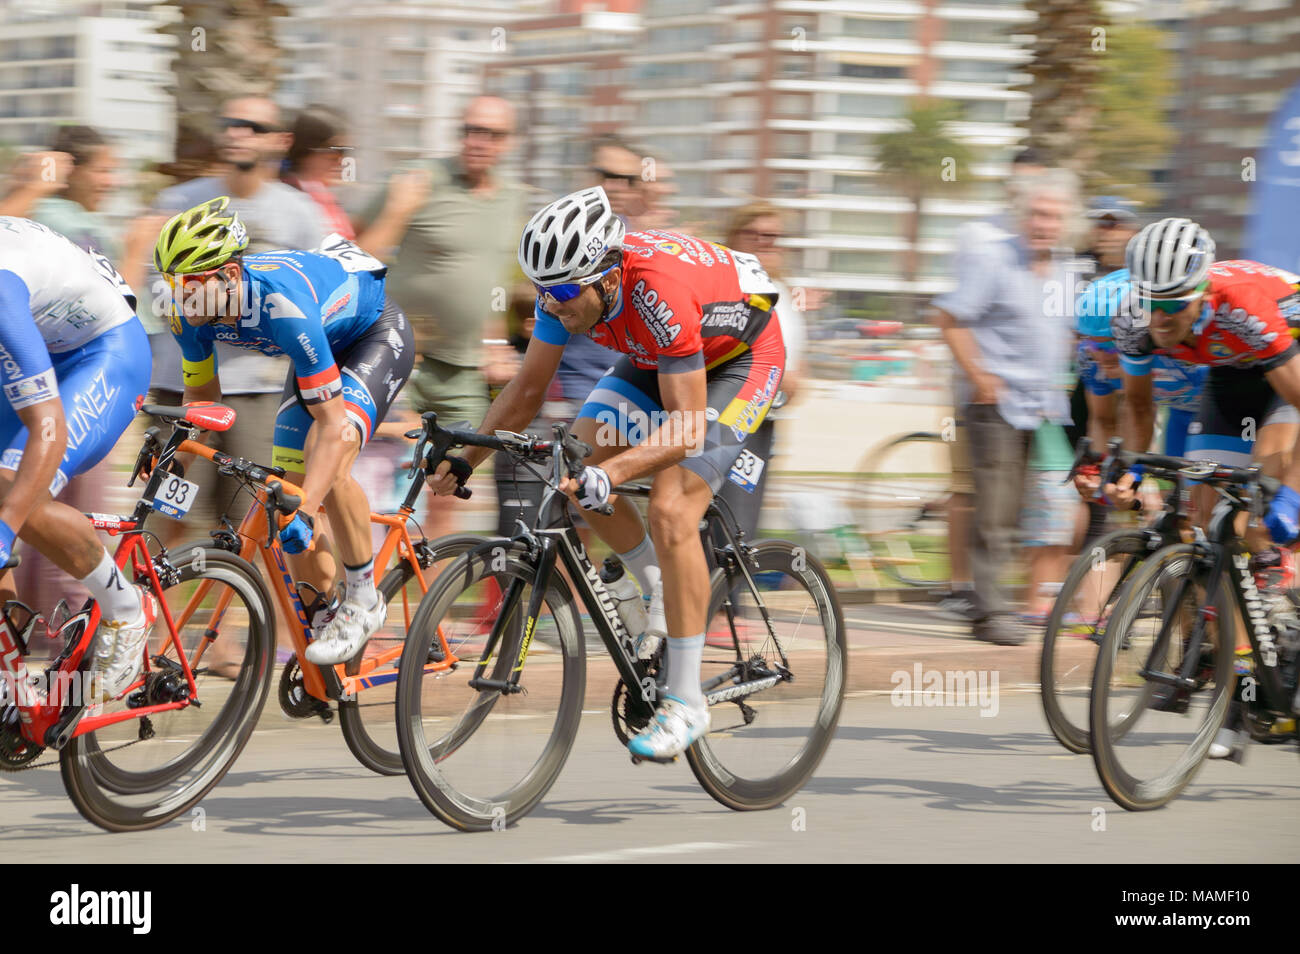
left=1089, top=545, right=1236, bottom=811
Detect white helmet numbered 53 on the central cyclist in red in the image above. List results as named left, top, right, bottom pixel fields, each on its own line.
left=519, top=186, right=627, bottom=285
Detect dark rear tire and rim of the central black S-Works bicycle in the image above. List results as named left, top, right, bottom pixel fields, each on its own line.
left=686, top=539, right=848, bottom=811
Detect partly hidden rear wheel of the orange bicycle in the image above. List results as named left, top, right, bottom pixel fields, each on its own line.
left=338, top=533, right=485, bottom=775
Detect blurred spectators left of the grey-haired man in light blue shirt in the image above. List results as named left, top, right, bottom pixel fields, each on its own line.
left=0, top=96, right=803, bottom=629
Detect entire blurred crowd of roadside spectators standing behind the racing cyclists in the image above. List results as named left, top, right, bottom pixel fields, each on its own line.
left=0, top=96, right=1180, bottom=657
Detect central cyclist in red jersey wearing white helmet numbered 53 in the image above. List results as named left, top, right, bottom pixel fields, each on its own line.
left=430, top=187, right=785, bottom=760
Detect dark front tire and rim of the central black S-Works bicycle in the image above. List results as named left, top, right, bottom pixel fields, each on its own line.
left=397, top=539, right=586, bottom=832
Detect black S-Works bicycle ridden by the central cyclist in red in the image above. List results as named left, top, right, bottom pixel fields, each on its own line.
left=397, top=413, right=848, bottom=831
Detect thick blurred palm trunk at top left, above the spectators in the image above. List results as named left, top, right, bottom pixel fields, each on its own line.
left=159, top=0, right=289, bottom=157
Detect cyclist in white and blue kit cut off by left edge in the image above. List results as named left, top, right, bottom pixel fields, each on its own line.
left=0, top=217, right=157, bottom=699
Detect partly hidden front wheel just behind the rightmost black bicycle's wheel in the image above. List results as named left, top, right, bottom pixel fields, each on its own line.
left=1039, top=530, right=1148, bottom=754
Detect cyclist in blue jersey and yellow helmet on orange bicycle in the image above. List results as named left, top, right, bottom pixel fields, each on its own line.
left=153, top=196, right=415, bottom=664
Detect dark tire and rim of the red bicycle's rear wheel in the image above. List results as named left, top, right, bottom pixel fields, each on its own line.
left=59, top=547, right=274, bottom=832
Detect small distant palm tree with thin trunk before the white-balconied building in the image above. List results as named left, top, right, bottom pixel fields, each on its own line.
left=875, top=100, right=971, bottom=321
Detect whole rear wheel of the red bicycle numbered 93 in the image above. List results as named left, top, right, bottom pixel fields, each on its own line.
left=59, top=546, right=274, bottom=832
